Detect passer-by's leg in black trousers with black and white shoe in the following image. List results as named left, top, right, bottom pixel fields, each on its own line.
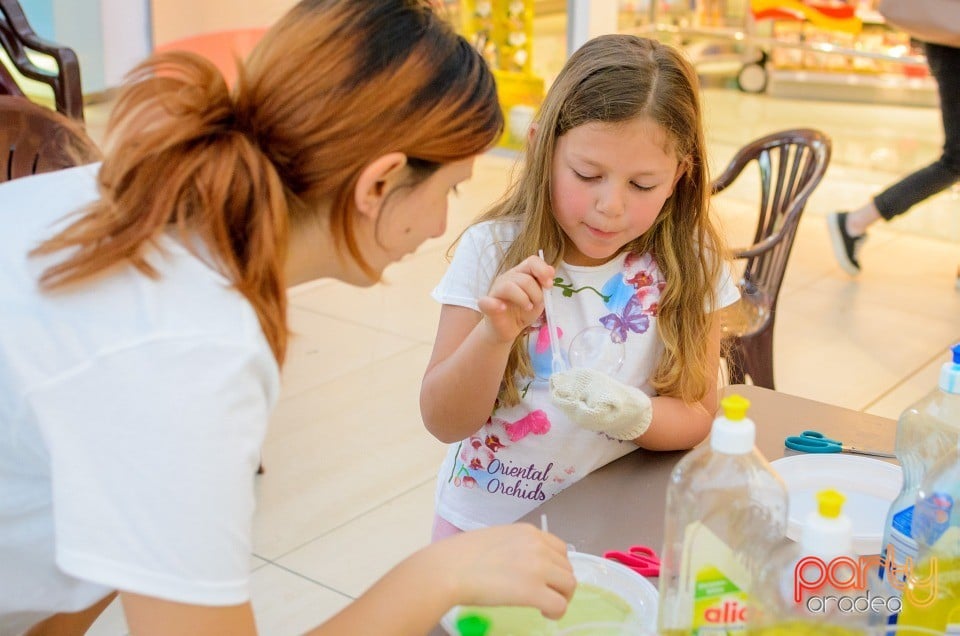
left=827, top=43, right=960, bottom=275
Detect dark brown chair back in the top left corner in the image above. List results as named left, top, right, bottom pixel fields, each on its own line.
left=0, top=0, right=83, bottom=121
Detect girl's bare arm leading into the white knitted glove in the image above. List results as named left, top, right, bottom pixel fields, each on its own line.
left=634, top=312, right=720, bottom=450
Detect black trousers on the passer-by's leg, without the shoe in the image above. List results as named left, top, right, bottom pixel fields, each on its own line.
left=873, top=43, right=960, bottom=221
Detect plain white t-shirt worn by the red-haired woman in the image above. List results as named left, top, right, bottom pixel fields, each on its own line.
left=0, top=165, right=279, bottom=636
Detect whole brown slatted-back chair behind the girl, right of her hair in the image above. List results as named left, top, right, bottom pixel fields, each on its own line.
left=712, top=129, right=831, bottom=389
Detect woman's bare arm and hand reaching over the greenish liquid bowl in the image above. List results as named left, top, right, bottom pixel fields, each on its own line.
left=120, top=524, right=577, bottom=636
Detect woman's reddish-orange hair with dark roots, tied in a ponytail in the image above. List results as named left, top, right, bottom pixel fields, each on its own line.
left=32, top=0, right=503, bottom=363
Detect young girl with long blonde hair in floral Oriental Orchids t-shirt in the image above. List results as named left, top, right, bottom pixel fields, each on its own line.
left=420, top=35, right=738, bottom=538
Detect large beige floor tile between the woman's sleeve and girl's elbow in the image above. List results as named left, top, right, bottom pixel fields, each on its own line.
left=254, top=345, right=445, bottom=559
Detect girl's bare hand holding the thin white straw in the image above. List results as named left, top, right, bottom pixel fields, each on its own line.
left=478, top=256, right=556, bottom=343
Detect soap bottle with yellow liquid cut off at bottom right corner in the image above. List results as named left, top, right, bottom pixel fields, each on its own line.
left=897, top=449, right=960, bottom=636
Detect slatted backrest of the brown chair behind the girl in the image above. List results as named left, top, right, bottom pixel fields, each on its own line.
left=712, top=129, right=831, bottom=313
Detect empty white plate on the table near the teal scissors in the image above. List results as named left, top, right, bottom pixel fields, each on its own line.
left=770, top=453, right=903, bottom=554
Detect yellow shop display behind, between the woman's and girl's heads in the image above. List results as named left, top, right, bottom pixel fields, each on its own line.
left=458, top=0, right=544, bottom=149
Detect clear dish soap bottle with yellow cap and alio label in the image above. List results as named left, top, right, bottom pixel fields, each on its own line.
left=658, top=395, right=787, bottom=634
